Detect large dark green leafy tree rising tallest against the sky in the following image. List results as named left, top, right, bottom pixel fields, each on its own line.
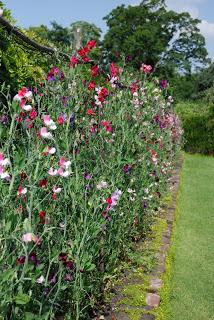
left=103, top=0, right=207, bottom=73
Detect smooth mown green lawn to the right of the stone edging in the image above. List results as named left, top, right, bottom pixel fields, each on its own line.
left=169, top=154, right=214, bottom=320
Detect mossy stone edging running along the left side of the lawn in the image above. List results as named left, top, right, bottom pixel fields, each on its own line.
left=102, top=156, right=183, bottom=320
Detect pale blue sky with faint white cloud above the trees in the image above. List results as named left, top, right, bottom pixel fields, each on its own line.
left=3, top=0, right=214, bottom=60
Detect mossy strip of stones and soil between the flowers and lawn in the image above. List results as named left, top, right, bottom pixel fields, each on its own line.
left=102, top=154, right=184, bottom=320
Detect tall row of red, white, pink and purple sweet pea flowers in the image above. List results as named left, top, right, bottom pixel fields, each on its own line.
left=0, top=41, right=180, bottom=320
